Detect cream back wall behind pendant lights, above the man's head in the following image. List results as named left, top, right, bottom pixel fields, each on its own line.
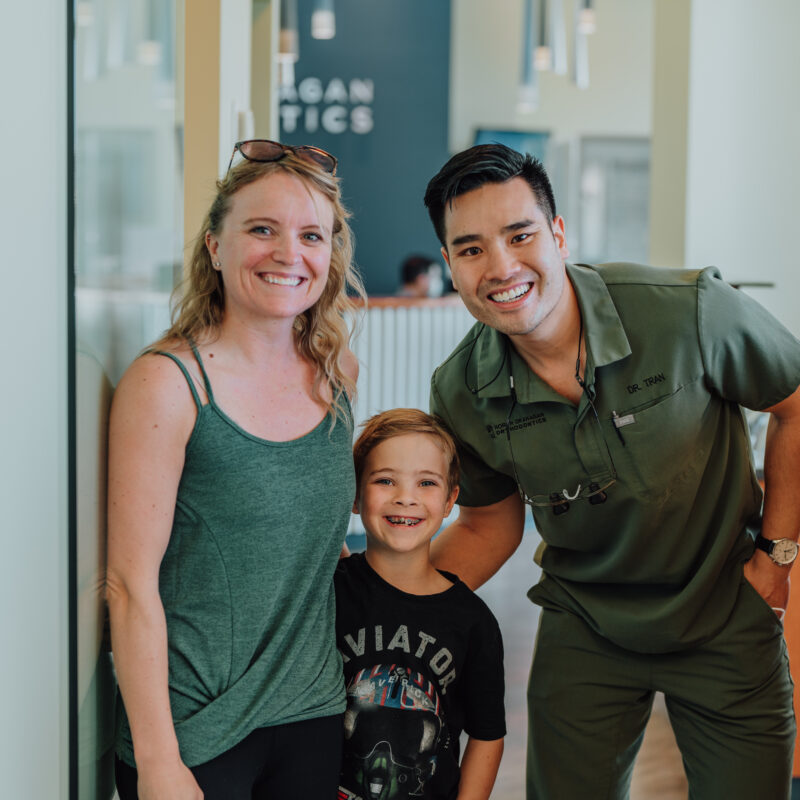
left=450, top=0, right=653, bottom=152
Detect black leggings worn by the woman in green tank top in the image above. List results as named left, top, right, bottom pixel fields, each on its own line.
left=116, top=715, right=343, bottom=800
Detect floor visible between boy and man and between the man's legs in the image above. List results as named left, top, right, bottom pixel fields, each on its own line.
left=478, top=532, right=688, bottom=800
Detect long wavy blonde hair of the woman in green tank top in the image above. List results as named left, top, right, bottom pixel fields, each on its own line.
left=158, top=153, right=366, bottom=423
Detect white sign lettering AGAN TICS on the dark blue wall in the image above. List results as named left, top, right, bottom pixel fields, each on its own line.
left=280, top=77, right=375, bottom=134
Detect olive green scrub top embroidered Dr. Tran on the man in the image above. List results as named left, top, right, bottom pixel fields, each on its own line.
left=431, top=264, right=800, bottom=653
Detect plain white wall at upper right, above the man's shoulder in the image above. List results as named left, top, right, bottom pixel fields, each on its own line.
left=686, top=0, right=800, bottom=334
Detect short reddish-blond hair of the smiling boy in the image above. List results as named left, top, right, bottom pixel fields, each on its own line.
left=353, top=408, right=459, bottom=494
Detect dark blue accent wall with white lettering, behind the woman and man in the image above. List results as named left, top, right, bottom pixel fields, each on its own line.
left=281, top=0, right=450, bottom=294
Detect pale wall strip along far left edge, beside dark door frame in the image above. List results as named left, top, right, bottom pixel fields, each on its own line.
left=0, top=0, right=68, bottom=800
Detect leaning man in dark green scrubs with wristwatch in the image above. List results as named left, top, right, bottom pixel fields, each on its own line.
left=425, top=145, right=800, bottom=800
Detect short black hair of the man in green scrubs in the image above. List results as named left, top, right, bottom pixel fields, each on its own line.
left=425, top=144, right=556, bottom=248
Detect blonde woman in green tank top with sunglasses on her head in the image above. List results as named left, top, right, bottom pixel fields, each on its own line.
left=108, top=140, right=363, bottom=800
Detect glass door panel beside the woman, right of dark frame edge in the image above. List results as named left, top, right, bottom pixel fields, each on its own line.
left=73, top=0, right=183, bottom=800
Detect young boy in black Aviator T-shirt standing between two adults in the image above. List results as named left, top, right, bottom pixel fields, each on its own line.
left=335, top=408, right=506, bottom=800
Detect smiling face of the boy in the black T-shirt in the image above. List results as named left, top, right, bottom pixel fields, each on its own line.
left=353, top=433, right=458, bottom=553
